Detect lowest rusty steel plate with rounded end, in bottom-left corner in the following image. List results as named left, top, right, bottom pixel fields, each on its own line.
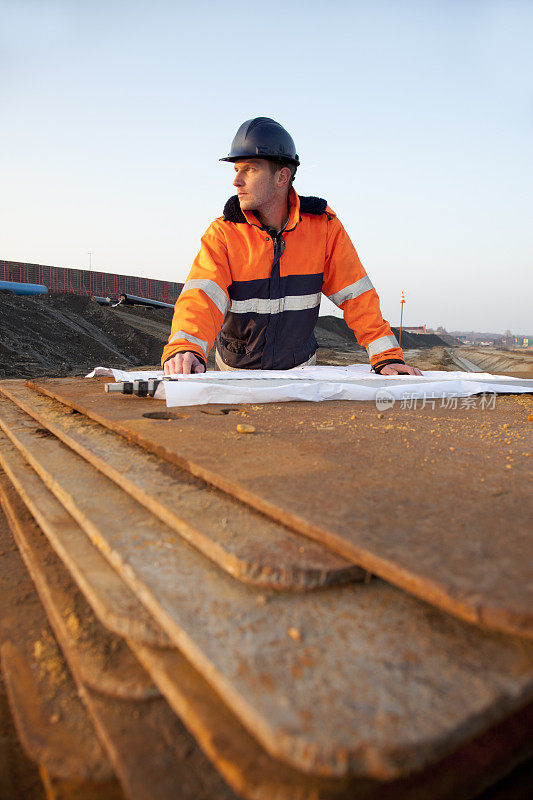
left=0, top=512, right=113, bottom=781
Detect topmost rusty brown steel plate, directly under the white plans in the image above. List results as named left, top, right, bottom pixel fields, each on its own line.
left=31, top=379, right=533, bottom=637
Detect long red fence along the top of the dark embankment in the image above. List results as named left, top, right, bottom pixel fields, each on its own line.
left=0, top=260, right=183, bottom=303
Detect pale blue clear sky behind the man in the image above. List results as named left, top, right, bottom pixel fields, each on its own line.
left=0, top=0, right=533, bottom=334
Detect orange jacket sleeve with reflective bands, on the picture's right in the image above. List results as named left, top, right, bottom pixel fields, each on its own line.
left=322, top=208, right=404, bottom=370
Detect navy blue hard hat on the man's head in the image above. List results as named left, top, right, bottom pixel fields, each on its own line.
left=220, top=117, right=300, bottom=166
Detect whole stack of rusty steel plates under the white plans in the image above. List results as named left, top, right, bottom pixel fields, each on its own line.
left=0, top=378, right=533, bottom=800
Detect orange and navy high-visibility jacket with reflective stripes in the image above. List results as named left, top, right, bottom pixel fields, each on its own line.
left=162, top=189, right=403, bottom=370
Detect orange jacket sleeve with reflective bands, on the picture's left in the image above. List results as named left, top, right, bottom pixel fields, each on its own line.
left=161, top=221, right=231, bottom=364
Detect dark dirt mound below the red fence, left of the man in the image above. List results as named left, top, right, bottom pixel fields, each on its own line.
left=0, top=293, right=166, bottom=378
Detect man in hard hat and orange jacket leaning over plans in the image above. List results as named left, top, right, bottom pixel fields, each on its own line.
left=162, top=117, right=421, bottom=375
